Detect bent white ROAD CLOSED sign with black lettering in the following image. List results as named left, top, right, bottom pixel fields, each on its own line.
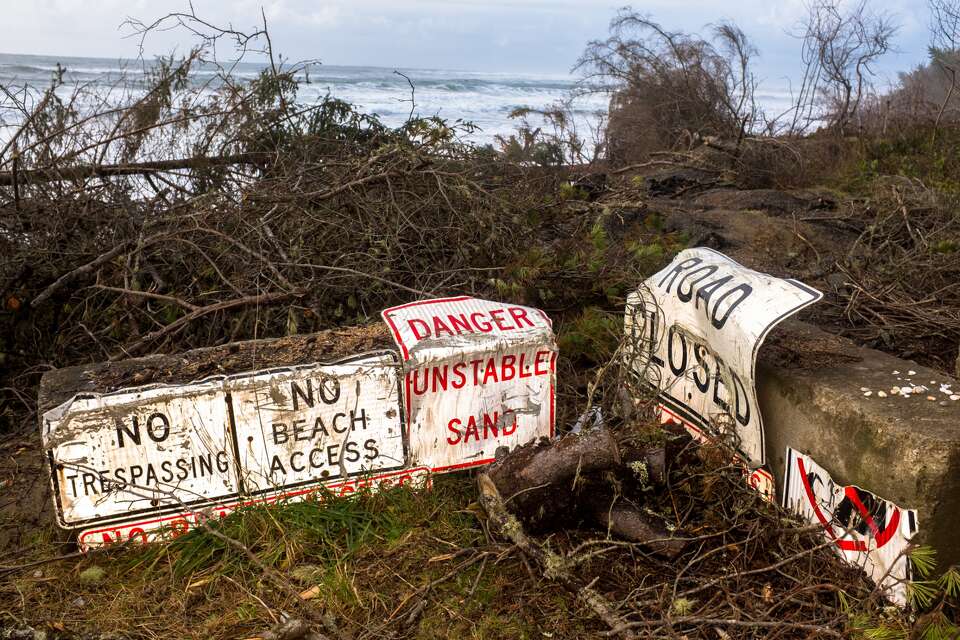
left=624, top=248, right=823, bottom=484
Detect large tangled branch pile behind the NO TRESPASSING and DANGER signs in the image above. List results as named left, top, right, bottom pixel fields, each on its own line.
left=0, top=36, right=568, bottom=430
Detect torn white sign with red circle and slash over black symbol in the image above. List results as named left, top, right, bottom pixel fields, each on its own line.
left=783, top=447, right=918, bottom=606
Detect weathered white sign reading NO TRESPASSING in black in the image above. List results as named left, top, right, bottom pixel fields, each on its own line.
left=42, top=381, right=238, bottom=527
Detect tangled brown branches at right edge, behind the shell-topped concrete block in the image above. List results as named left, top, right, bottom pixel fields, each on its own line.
left=816, top=179, right=960, bottom=371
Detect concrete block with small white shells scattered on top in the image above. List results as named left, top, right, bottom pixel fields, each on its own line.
left=757, top=321, right=960, bottom=569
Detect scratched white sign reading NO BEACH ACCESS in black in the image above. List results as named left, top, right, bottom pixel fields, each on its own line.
left=225, top=353, right=406, bottom=495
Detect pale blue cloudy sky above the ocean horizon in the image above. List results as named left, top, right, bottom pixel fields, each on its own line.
left=0, top=0, right=927, bottom=80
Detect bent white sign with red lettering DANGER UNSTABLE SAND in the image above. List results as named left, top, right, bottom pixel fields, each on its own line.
left=382, top=296, right=557, bottom=472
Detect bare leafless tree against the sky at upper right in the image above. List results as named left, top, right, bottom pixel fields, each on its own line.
left=791, top=0, right=898, bottom=135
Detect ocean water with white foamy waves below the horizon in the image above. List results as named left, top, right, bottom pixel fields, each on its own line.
left=0, top=52, right=607, bottom=144
